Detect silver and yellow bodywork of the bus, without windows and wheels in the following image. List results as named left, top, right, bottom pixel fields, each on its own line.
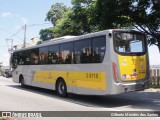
left=13, top=30, right=148, bottom=95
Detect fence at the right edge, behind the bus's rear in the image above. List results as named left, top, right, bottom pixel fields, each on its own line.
left=150, top=66, right=160, bottom=88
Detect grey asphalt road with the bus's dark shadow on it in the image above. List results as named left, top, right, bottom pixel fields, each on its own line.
left=0, top=76, right=160, bottom=120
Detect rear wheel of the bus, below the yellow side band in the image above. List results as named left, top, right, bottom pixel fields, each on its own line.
left=56, top=79, right=68, bottom=97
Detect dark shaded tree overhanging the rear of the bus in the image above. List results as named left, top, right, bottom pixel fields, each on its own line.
left=95, top=0, right=160, bottom=51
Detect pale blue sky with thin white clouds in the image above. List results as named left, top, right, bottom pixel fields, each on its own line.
left=0, top=0, right=160, bottom=66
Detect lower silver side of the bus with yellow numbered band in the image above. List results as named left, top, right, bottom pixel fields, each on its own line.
left=13, top=64, right=107, bottom=95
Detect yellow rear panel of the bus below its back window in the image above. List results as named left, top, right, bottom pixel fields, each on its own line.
left=118, top=55, right=147, bottom=81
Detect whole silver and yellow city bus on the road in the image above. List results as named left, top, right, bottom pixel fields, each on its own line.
left=11, top=29, right=149, bottom=97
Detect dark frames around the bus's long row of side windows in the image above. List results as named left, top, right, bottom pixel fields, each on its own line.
left=10, top=35, right=107, bottom=67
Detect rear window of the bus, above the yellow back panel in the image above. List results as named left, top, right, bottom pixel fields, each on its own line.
left=114, top=32, right=146, bottom=54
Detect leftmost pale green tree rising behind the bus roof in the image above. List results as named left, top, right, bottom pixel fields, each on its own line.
left=39, top=3, right=69, bottom=41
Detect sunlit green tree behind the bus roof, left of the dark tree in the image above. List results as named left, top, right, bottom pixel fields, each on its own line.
left=50, top=0, right=95, bottom=37
